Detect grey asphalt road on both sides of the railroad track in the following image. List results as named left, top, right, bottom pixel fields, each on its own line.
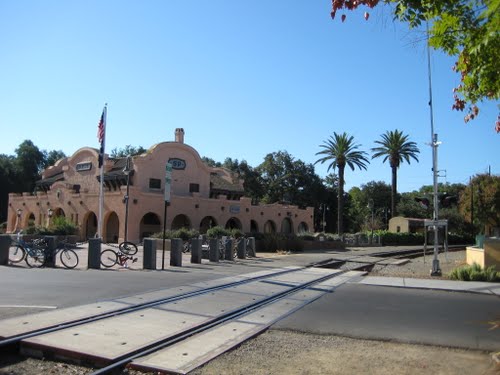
left=0, top=254, right=500, bottom=351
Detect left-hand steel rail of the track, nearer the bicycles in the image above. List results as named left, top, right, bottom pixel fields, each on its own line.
left=0, top=267, right=300, bottom=347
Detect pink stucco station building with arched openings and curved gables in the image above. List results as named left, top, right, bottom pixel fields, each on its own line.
left=7, top=129, right=313, bottom=242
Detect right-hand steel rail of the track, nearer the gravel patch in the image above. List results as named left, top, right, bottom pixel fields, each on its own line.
left=90, top=270, right=352, bottom=375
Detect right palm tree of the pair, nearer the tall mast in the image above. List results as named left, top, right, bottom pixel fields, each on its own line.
left=372, top=129, right=420, bottom=217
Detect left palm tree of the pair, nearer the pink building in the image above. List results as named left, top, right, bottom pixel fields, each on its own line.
left=314, top=132, right=370, bottom=235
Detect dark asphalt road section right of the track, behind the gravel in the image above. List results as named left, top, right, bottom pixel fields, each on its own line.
left=273, top=284, right=500, bottom=351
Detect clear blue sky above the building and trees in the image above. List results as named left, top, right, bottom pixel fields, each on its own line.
left=0, top=0, right=500, bottom=192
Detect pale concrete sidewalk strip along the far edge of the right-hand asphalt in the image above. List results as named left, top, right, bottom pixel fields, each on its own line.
left=357, top=276, right=500, bottom=296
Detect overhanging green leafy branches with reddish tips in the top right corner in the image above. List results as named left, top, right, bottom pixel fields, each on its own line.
left=331, top=0, right=500, bottom=132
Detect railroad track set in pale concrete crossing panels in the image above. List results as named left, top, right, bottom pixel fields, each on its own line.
left=0, top=267, right=363, bottom=375
